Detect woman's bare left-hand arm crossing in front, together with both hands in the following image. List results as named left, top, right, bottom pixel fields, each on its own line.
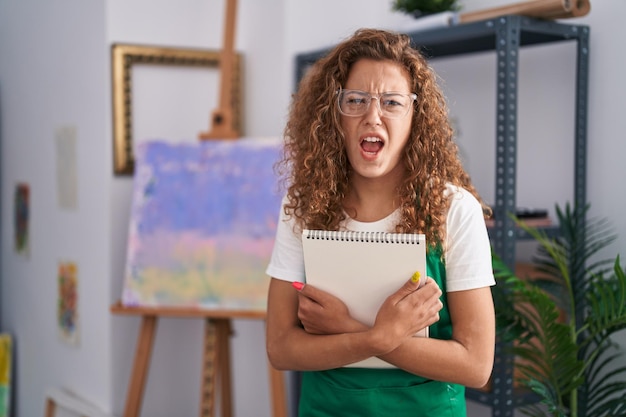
left=266, top=279, right=441, bottom=370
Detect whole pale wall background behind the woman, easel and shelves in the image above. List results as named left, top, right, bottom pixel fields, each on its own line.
left=0, top=0, right=626, bottom=417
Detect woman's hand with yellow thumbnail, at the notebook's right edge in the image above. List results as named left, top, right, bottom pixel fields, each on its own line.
left=373, top=278, right=443, bottom=351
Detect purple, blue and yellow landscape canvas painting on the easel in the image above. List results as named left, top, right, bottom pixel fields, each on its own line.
left=122, top=139, right=282, bottom=311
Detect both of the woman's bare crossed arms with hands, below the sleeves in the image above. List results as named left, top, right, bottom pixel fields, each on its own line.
left=267, top=272, right=495, bottom=388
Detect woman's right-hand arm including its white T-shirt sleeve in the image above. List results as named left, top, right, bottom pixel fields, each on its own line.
left=370, top=186, right=495, bottom=388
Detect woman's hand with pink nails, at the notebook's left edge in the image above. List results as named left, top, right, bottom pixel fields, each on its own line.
left=293, top=282, right=367, bottom=334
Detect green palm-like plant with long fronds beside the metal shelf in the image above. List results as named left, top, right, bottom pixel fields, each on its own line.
left=494, top=205, right=626, bottom=417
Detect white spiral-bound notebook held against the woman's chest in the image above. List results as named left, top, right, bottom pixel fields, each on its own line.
left=302, top=229, right=428, bottom=368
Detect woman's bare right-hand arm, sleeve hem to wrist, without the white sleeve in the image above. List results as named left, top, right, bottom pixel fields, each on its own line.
left=381, top=287, right=495, bottom=388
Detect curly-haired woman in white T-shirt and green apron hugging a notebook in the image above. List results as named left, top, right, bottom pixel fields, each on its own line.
left=267, top=29, right=495, bottom=417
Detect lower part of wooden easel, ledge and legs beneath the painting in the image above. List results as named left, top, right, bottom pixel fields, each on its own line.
left=111, top=302, right=287, bottom=417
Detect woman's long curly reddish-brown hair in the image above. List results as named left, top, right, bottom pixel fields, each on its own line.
left=278, top=29, right=488, bottom=247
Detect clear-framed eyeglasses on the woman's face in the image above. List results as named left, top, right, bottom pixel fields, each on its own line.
left=337, top=89, right=417, bottom=119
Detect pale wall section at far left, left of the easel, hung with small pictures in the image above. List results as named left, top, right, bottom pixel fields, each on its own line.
left=0, top=0, right=111, bottom=416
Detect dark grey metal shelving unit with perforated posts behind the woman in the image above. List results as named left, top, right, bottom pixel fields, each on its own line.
left=296, top=15, right=589, bottom=417
